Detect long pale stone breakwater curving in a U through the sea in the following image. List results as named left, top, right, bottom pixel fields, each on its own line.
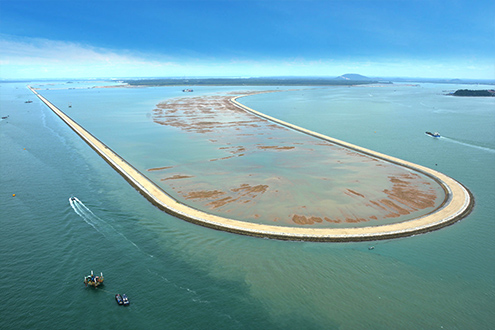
left=29, top=87, right=473, bottom=241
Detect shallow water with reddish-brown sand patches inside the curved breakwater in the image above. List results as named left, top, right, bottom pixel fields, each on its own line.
left=148, top=92, right=446, bottom=228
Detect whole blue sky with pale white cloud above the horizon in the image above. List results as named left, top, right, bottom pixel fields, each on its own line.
left=0, top=0, right=495, bottom=79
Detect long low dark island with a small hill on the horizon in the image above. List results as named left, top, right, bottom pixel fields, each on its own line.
left=124, top=74, right=388, bottom=86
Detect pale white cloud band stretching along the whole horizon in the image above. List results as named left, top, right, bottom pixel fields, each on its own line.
left=0, top=34, right=495, bottom=79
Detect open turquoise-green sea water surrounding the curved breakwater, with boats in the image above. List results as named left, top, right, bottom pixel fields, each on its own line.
left=0, top=84, right=495, bottom=329
